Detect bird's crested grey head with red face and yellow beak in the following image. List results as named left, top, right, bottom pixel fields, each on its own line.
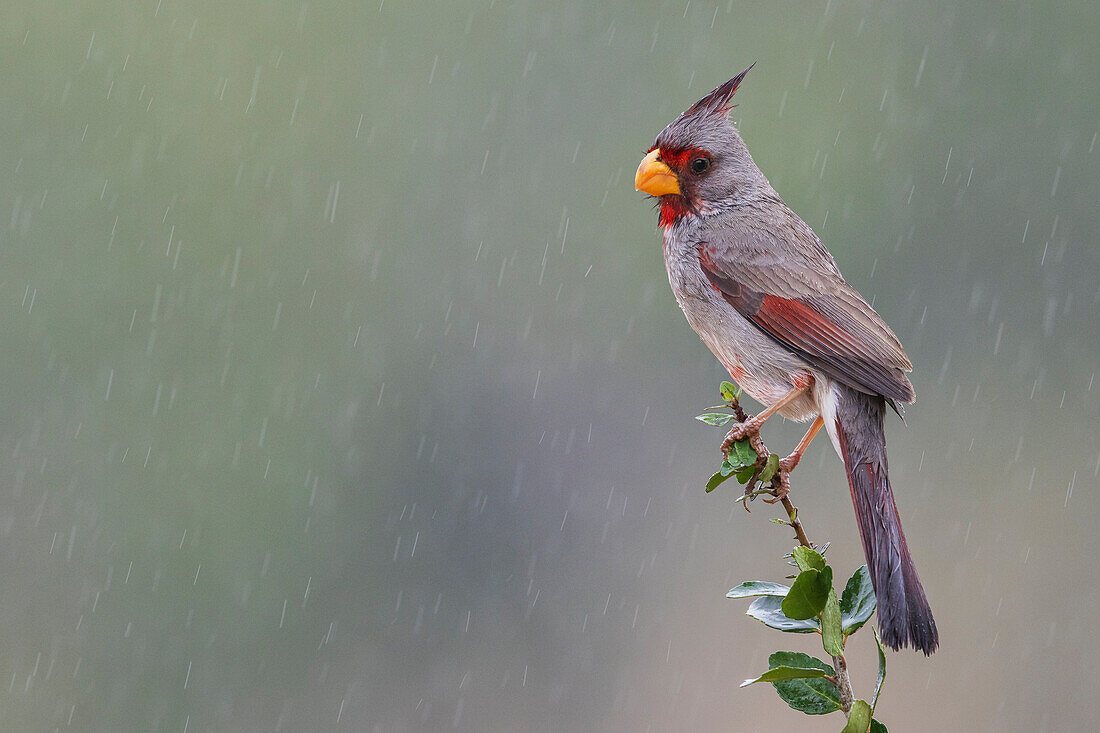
left=634, top=64, right=768, bottom=227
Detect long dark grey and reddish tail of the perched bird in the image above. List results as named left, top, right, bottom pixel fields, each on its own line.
left=835, top=385, right=939, bottom=655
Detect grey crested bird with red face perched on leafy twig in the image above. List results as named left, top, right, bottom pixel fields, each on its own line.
left=635, top=64, right=939, bottom=655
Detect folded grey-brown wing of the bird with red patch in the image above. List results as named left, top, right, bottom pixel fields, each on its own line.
left=699, top=222, right=914, bottom=403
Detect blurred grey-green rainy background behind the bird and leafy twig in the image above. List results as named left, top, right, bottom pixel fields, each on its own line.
left=0, top=0, right=1100, bottom=732
